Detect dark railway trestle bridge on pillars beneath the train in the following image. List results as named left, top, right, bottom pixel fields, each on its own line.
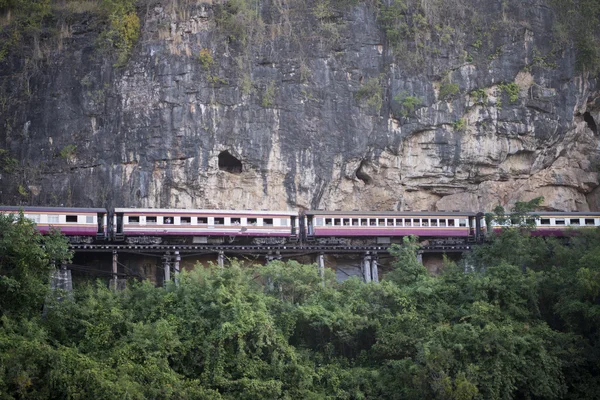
left=53, top=242, right=472, bottom=290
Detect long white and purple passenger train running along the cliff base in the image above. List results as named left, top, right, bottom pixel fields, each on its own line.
left=0, top=206, right=600, bottom=245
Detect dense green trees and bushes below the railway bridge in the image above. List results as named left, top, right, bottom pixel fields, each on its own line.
left=0, top=212, right=600, bottom=399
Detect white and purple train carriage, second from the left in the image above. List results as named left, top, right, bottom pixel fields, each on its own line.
left=114, top=208, right=297, bottom=243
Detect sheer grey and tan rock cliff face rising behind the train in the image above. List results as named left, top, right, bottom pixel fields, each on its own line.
left=0, top=0, right=600, bottom=211
